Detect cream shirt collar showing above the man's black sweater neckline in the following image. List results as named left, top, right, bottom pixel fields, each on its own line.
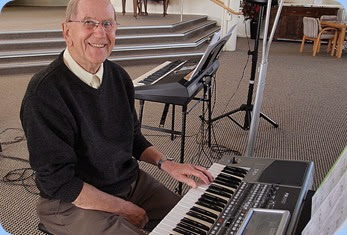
left=63, top=48, right=104, bottom=87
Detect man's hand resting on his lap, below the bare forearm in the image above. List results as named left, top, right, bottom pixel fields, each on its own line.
left=119, top=201, right=148, bottom=229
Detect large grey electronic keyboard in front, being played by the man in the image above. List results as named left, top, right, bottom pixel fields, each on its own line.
left=151, top=157, right=313, bottom=235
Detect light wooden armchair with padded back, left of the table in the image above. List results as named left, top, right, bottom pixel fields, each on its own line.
left=300, top=17, right=337, bottom=56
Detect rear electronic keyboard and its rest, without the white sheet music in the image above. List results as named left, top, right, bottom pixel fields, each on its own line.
left=133, top=60, right=219, bottom=105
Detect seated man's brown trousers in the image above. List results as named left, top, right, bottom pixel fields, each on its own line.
left=37, top=170, right=180, bottom=235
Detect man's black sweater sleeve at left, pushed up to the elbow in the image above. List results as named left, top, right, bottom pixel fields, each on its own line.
left=20, top=95, right=83, bottom=202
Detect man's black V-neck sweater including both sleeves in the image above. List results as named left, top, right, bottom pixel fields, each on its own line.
left=20, top=54, right=151, bottom=202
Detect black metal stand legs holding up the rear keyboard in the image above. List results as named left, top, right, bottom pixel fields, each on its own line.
left=139, top=75, right=212, bottom=195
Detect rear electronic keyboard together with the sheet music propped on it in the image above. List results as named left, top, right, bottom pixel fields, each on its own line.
left=134, top=25, right=236, bottom=105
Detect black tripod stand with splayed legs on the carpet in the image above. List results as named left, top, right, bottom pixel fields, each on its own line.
left=211, top=0, right=278, bottom=130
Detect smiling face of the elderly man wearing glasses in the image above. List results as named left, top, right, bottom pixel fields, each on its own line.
left=63, top=0, right=115, bottom=73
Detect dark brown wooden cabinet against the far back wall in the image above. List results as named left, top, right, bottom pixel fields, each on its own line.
left=270, top=6, right=339, bottom=40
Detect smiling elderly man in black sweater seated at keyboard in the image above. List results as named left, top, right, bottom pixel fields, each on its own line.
left=21, top=0, right=212, bottom=235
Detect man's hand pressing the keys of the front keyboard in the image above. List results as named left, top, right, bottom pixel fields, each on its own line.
left=161, top=161, right=213, bottom=188
